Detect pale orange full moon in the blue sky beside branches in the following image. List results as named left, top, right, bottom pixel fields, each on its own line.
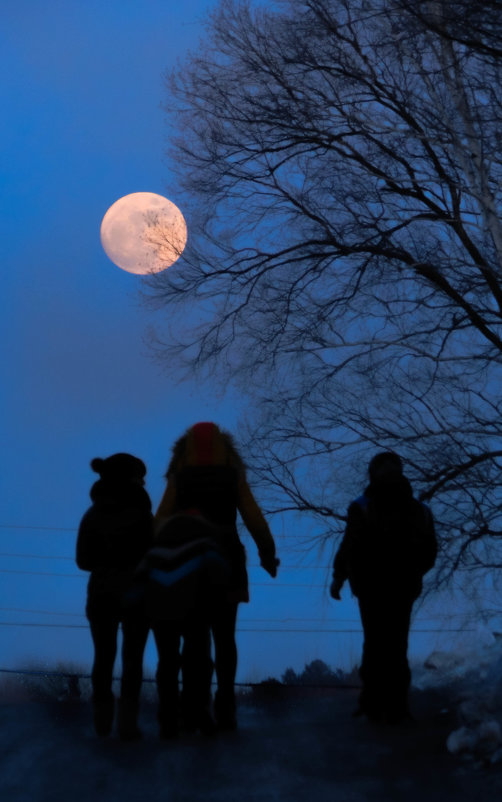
left=101, top=192, right=187, bottom=275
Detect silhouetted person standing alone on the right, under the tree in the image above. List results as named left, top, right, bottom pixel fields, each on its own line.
left=331, top=451, right=437, bottom=723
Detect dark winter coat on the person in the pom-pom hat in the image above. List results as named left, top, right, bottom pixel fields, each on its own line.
left=76, top=479, right=153, bottom=617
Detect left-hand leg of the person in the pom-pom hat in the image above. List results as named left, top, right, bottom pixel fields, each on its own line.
left=88, top=610, right=119, bottom=735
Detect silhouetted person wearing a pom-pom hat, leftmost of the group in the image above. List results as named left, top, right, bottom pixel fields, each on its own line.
left=77, top=454, right=153, bottom=740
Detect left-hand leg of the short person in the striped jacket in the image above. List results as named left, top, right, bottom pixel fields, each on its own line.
left=152, top=621, right=181, bottom=738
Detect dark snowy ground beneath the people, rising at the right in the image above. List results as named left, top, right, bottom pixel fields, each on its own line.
left=0, top=631, right=502, bottom=802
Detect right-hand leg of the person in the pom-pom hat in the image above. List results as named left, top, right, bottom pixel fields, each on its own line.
left=117, top=615, right=149, bottom=740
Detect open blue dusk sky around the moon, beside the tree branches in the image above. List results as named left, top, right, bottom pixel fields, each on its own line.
left=0, top=0, right=452, bottom=680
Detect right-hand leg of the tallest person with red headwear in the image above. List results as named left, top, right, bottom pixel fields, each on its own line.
left=211, top=602, right=237, bottom=729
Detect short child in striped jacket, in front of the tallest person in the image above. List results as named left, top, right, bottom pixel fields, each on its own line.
left=138, top=510, right=231, bottom=738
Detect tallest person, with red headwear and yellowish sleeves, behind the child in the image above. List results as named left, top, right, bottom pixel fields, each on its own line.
left=155, top=422, right=279, bottom=729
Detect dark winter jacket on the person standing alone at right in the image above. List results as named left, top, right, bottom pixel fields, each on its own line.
left=333, top=476, right=437, bottom=599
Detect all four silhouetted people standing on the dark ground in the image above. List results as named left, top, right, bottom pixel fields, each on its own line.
left=76, top=422, right=437, bottom=740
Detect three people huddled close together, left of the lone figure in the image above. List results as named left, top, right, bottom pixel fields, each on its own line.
left=76, top=422, right=279, bottom=740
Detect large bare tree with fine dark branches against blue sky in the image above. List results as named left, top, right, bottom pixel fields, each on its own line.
left=156, top=0, right=502, bottom=581
